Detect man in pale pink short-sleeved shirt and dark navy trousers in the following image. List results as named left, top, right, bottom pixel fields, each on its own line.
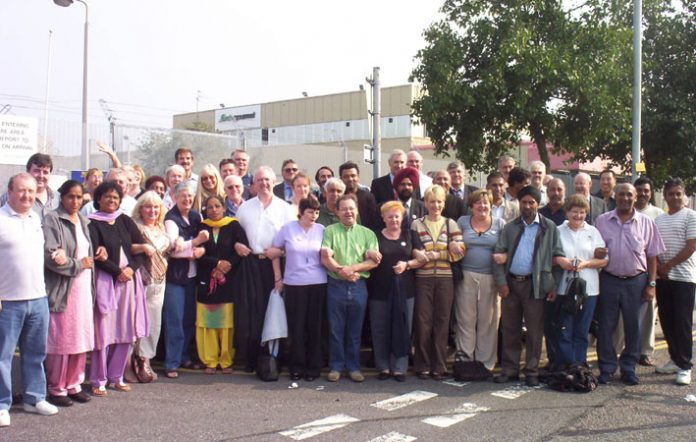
left=595, top=183, right=665, bottom=385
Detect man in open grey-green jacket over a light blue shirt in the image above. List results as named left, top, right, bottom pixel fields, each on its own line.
left=494, top=186, right=564, bottom=387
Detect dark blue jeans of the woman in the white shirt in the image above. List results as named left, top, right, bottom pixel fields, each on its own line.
left=554, top=295, right=598, bottom=368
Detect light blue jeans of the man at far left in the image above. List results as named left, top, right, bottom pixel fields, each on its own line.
left=0, top=297, right=49, bottom=410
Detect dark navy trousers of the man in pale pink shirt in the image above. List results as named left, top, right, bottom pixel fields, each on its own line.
left=597, top=272, right=648, bottom=374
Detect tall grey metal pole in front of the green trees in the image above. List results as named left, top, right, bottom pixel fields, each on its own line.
left=631, top=0, right=643, bottom=181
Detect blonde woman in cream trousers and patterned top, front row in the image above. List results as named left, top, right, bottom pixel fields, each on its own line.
left=133, top=190, right=171, bottom=382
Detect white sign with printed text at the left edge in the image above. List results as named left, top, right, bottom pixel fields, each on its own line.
left=0, top=115, right=38, bottom=166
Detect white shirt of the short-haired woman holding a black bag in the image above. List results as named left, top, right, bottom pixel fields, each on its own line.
left=558, top=220, right=606, bottom=296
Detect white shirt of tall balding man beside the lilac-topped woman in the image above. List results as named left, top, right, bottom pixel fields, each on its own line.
left=237, top=195, right=297, bottom=255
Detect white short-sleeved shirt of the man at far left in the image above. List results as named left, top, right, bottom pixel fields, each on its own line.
left=0, top=204, right=46, bottom=301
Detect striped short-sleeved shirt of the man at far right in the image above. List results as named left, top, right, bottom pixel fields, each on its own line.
left=655, top=207, right=696, bottom=283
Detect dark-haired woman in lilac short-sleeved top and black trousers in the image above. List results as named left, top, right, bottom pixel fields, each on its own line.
left=269, top=196, right=326, bottom=381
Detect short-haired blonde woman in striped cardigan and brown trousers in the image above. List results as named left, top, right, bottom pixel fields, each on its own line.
left=411, top=185, right=466, bottom=380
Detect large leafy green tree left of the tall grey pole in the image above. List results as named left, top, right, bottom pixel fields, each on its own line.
left=411, top=0, right=632, bottom=170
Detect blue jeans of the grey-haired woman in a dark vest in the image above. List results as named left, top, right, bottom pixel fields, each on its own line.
left=163, top=278, right=196, bottom=370
